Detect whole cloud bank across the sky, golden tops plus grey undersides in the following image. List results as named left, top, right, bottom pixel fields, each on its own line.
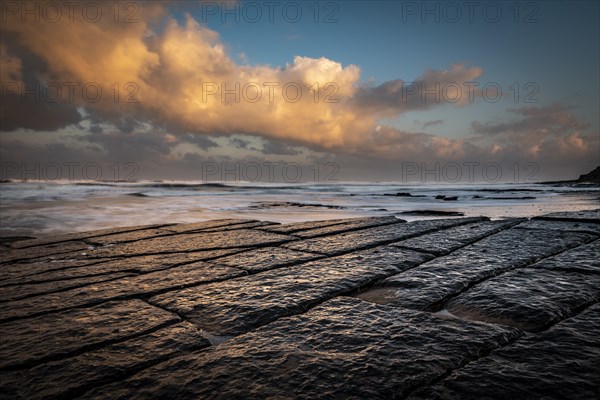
left=0, top=2, right=598, bottom=180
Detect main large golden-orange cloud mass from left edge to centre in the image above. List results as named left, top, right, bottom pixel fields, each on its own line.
left=3, top=3, right=482, bottom=152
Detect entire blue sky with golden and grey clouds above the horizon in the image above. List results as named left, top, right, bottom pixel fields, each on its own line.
left=0, top=0, right=600, bottom=183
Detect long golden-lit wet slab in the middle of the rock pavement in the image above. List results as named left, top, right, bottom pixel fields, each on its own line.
left=149, top=247, right=432, bottom=335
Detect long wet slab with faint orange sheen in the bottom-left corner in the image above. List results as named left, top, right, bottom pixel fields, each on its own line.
left=0, top=322, right=210, bottom=400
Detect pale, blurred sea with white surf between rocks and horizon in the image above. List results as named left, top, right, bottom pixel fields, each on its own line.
left=0, top=181, right=600, bottom=237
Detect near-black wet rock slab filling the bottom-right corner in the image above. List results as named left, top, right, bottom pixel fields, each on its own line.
left=408, top=304, right=600, bottom=400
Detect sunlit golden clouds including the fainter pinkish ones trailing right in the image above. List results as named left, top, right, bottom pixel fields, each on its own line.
left=0, top=2, right=590, bottom=166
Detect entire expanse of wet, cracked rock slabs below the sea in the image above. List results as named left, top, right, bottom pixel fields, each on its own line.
left=0, top=210, right=600, bottom=400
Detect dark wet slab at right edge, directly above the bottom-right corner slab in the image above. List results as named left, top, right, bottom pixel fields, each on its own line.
left=446, top=268, right=600, bottom=332
